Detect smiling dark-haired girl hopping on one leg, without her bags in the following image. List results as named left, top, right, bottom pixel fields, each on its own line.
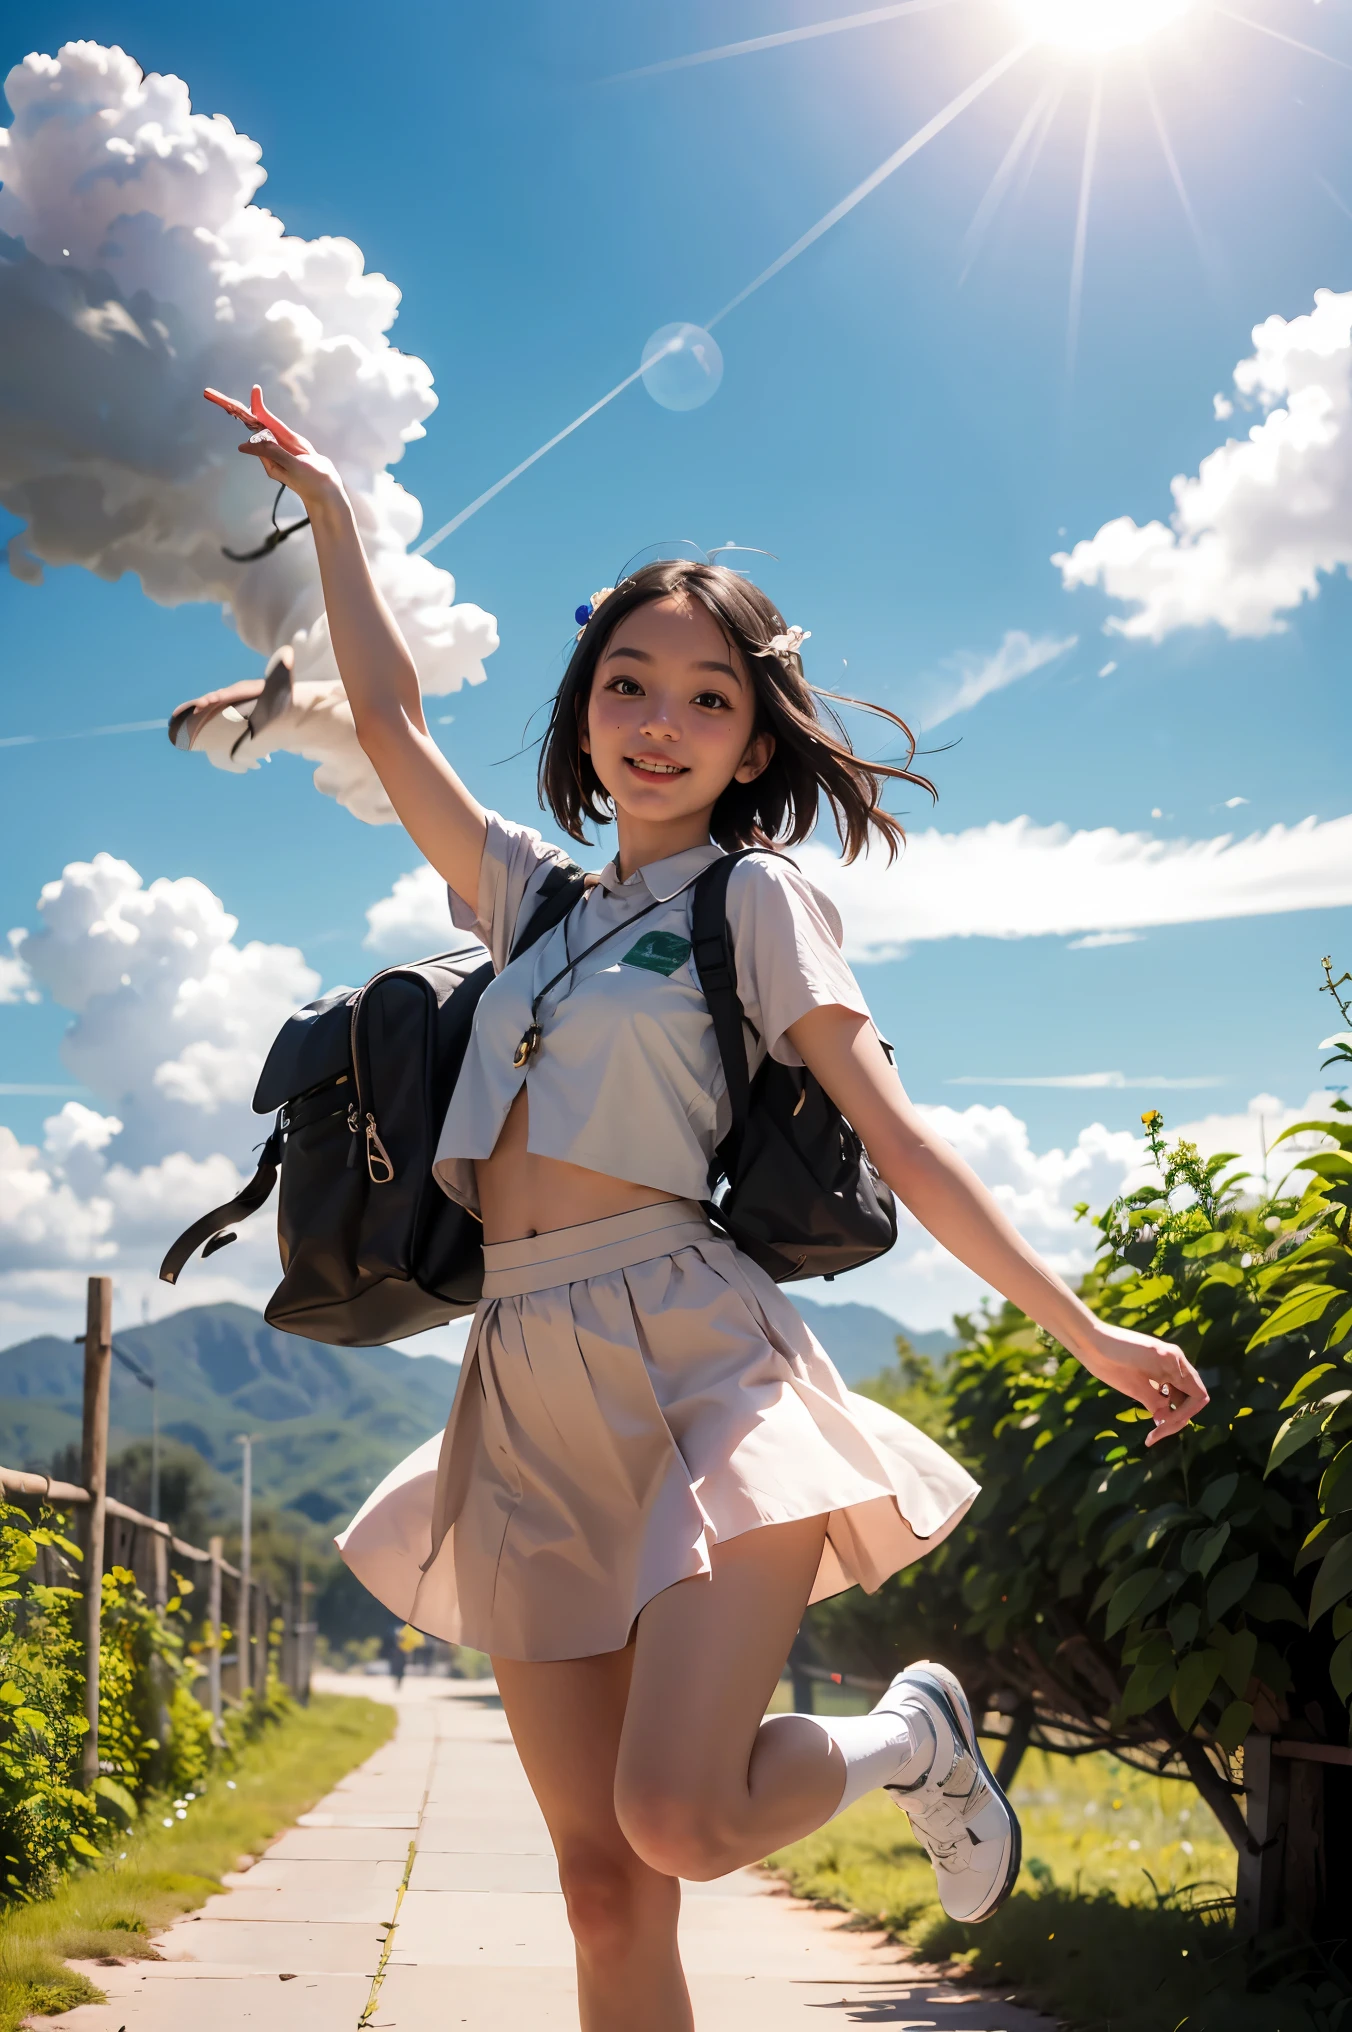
left=211, top=388, right=1206, bottom=2032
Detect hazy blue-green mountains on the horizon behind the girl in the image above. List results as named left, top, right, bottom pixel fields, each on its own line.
left=0, top=1292, right=958, bottom=1524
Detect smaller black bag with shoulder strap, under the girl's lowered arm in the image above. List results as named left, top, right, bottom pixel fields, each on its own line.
left=691, top=847, right=897, bottom=1284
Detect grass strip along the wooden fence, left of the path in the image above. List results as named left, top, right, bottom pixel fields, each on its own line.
left=0, top=1695, right=394, bottom=2032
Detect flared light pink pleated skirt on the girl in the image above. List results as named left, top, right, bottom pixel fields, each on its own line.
left=337, top=1199, right=978, bottom=1660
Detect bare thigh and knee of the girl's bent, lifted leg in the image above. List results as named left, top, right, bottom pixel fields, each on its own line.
left=616, top=1518, right=846, bottom=1880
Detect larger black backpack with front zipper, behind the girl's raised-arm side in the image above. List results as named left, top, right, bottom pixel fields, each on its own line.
left=161, top=864, right=586, bottom=1347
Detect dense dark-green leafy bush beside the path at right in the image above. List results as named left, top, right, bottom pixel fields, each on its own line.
left=813, top=965, right=1352, bottom=1845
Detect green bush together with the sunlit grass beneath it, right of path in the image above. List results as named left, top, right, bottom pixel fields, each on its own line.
left=773, top=961, right=1352, bottom=2032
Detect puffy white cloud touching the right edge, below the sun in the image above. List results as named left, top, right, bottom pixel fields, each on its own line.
left=1053, top=289, right=1352, bottom=642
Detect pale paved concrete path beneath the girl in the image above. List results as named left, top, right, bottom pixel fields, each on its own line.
left=37, top=1676, right=1051, bottom=2032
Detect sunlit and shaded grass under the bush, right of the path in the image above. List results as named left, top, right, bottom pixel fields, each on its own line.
left=769, top=1731, right=1284, bottom=2032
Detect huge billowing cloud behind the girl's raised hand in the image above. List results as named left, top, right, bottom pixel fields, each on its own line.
left=0, top=43, right=498, bottom=823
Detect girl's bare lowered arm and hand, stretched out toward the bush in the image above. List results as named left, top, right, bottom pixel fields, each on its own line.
left=787, top=1006, right=1208, bottom=1447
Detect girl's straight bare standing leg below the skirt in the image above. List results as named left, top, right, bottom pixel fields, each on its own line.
left=494, top=1646, right=693, bottom=2032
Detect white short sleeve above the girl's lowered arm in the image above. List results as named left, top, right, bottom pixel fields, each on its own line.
left=728, top=853, right=868, bottom=1065
